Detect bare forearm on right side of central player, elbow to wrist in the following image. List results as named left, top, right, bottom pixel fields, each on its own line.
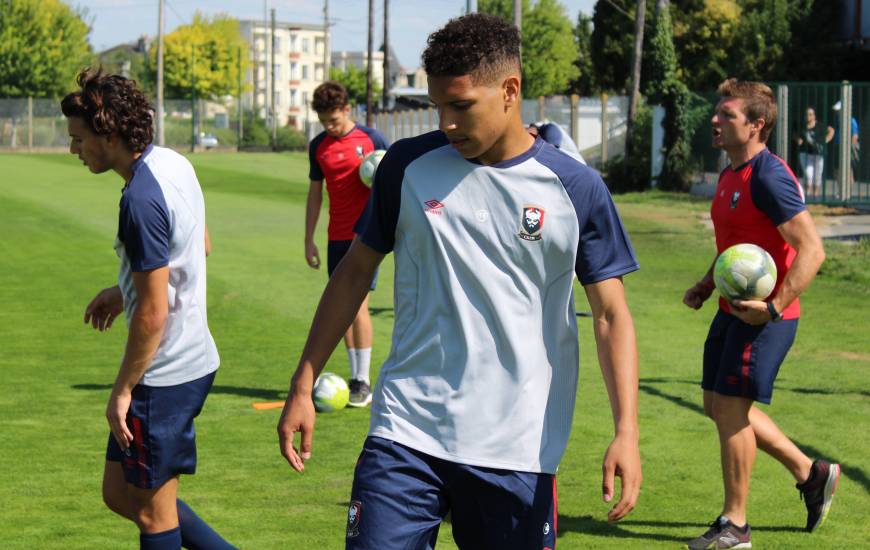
left=595, top=308, right=639, bottom=437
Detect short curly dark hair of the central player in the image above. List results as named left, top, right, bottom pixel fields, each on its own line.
left=423, top=13, right=522, bottom=84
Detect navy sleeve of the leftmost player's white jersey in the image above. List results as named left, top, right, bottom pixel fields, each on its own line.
left=118, top=174, right=171, bottom=272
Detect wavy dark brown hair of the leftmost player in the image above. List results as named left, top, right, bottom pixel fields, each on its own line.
left=60, top=68, right=154, bottom=153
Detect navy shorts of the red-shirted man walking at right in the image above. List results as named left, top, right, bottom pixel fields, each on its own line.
left=701, top=310, right=798, bottom=404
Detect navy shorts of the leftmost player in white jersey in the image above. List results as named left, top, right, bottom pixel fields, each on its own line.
left=106, top=372, right=215, bottom=489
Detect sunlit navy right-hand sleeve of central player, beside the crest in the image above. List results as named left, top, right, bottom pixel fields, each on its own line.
left=537, top=148, right=640, bottom=285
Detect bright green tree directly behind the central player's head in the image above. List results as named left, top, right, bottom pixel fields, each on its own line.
left=477, top=0, right=578, bottom=97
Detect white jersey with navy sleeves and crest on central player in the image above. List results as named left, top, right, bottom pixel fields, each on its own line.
left=357, top=131, right=638, bottom=473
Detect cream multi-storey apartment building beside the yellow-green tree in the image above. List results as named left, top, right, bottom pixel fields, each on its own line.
left=239, top=20, right=329, bottom=130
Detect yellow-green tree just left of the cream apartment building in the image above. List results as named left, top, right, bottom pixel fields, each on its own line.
left=149, top=12, right=248, bottom=99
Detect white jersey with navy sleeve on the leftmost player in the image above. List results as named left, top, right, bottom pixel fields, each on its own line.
left=115, top=146, right=220, bottom=386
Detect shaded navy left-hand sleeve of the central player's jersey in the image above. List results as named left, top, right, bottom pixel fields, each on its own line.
left=354, top=131, right=448, bottom=254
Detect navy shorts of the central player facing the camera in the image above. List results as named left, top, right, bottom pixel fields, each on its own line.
left=345, top=437, right=557, bottom=550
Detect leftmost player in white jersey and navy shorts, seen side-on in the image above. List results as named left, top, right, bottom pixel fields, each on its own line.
left=61, top=69, right=233, bottom=550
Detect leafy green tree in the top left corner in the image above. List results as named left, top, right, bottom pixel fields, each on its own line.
left=0, top=0, right=92, bottom=97
